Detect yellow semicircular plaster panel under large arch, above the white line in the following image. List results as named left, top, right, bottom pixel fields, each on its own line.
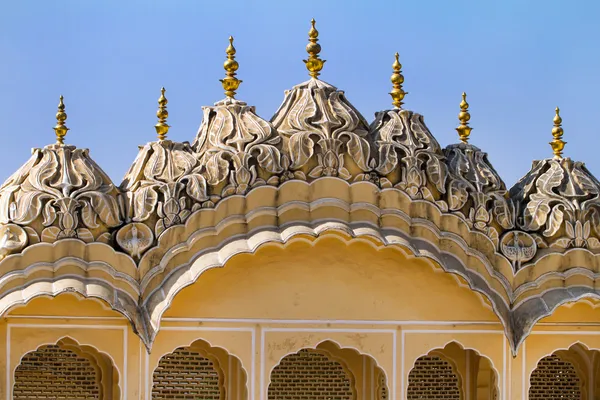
left=164, top=238, right=498, bottom=321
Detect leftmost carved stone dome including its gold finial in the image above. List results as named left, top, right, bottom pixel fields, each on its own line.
left=0, top=96, right=121, bottom=257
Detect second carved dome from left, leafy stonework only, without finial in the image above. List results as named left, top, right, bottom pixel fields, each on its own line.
left=121, top=140, right=209, bottom=241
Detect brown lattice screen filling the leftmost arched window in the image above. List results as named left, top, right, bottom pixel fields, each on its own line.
left=13, top=345, right=101, bottom=400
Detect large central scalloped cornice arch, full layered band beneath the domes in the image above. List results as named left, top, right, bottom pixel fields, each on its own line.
left=139, top=177, right=512, bottom=342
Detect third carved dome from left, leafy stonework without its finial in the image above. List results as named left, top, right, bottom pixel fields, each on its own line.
left=193, top=97, right=283, bottom=198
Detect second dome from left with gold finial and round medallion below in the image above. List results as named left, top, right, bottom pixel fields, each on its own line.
left=116, top=88, right=214, bottom=257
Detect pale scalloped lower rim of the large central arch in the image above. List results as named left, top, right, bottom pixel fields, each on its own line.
left=140, top=221, right=513, bottom=345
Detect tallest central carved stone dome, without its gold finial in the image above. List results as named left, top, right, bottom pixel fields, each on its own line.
left=271, top=79, right=374, bottom=181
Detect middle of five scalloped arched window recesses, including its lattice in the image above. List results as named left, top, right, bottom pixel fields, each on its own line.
left=262, top=339, right=394, bottom=400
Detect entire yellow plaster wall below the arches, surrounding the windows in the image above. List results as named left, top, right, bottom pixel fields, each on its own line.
left=0, top=237, right=600, bottom=400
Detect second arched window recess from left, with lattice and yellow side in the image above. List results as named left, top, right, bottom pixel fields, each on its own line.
left=150, top=339, right=250, bottom=399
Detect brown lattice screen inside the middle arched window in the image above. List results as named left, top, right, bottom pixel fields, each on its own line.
left=268, top=349, right=354, bottom=400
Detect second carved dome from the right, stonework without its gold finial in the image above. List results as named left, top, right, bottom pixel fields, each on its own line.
left=444, top=143, right=514, bottom=246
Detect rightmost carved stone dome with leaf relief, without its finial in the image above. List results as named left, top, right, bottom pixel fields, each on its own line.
left=510, top=158, right=600, bottom=250
